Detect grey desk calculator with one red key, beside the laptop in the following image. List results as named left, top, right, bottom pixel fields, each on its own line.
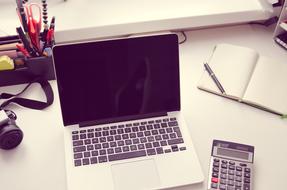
left=207, top=140, right=254, bottom=190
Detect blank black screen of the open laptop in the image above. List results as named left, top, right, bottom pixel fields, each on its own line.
left=53, top=34, right=180, bottom=126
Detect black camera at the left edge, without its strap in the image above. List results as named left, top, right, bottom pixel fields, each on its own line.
left=0, top=110, right=23, bottom=150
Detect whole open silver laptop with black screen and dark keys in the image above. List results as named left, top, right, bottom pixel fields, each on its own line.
left=53, top=34, right=203, bottom=190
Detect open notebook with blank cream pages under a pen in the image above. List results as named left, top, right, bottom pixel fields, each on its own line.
left=197, top=44, right=287, bottom=116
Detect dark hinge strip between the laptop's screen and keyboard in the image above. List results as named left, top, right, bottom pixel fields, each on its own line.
left=79, top=112, right=167, bottom=127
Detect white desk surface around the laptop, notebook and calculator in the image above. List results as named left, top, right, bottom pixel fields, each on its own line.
left=0, top=25, right=287, bottom=190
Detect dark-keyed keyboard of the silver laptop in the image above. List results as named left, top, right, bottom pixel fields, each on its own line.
left=72, top=117, right=186, bottom=166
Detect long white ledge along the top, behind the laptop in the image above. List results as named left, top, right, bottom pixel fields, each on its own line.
left=0, top=0, right=273, bottom=39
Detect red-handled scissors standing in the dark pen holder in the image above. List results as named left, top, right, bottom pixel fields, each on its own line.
left=25, top=3, right=42, bottom=52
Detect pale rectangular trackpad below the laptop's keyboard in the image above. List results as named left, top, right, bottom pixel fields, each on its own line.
left=112, top=159, right=160, bottom=190
